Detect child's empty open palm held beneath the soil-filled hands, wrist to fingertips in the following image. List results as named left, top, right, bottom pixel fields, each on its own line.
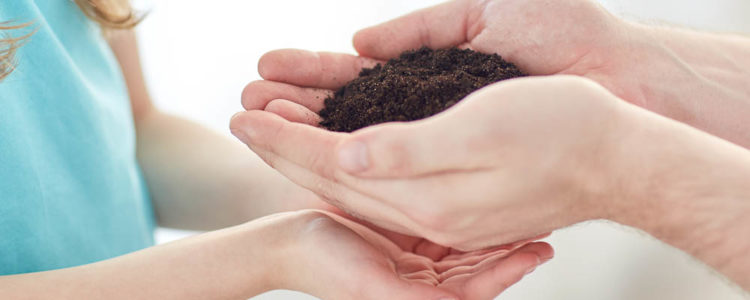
left=274, top=211, right=553, bottom=300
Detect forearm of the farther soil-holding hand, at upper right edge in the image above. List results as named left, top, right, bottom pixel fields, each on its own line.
left=631, top=24, right=750, bottom=148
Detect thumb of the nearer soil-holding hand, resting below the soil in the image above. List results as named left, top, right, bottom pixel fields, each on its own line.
left=335, top=111, right=489, bottom=178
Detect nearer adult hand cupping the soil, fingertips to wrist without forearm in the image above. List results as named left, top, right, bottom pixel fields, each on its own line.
left=232, top=76, right=626, bottom=250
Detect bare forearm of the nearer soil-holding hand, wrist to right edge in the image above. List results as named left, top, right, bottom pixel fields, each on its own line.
left=613, top=103, right=750, bottom=290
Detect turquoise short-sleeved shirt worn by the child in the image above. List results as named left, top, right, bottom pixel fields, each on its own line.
left=0, top=0, right=154, bottom=275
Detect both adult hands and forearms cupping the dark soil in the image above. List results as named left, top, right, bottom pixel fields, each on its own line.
left=231, top=0, right=750, bottom=289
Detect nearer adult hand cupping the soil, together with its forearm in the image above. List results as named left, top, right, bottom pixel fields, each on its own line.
left=232, top=76, right=750, bottom=289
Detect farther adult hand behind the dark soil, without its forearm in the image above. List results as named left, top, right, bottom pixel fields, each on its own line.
left=242, top=0, right=656, bottom=118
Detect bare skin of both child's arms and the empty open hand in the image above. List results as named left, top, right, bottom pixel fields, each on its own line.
left=0, top=25, right=553, bottom=300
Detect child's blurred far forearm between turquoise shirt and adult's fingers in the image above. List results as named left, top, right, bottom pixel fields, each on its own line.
left=138, top=110, right=324, bottom=230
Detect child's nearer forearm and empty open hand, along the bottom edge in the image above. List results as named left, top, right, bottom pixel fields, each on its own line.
left=0, top=210, right=553, bottom=300
